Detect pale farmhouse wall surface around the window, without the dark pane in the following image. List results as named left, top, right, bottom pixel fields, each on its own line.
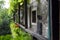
left=28, top=0, right=49, bottom=38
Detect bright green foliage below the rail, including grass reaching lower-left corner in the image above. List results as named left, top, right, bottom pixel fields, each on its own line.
left=0, top=22, right=32, bottom=40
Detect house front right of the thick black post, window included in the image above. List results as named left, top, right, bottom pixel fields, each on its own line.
left=28, top=0, right=49, bottom=38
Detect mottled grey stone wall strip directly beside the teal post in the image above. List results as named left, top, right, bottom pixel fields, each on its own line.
left=40, top=0, right=49, bottom=38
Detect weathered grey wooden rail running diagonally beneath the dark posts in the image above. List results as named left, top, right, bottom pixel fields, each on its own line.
left=16, top=24, right=48, bottom=40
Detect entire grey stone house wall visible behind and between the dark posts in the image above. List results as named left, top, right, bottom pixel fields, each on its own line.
left=14, top=0, right=49, bottom=38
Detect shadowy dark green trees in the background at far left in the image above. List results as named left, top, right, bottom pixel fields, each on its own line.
left=0, top=1, right=10, bottom=35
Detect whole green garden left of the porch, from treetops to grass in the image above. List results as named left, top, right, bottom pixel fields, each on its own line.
left=0, top=0, right=32, bottom=40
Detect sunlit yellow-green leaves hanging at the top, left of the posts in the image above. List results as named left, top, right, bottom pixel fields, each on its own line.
left=8, top=0, right=30, bottom=15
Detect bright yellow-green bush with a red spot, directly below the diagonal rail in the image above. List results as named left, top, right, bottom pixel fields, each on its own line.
left=10, top=22, right=32, bottom=40
